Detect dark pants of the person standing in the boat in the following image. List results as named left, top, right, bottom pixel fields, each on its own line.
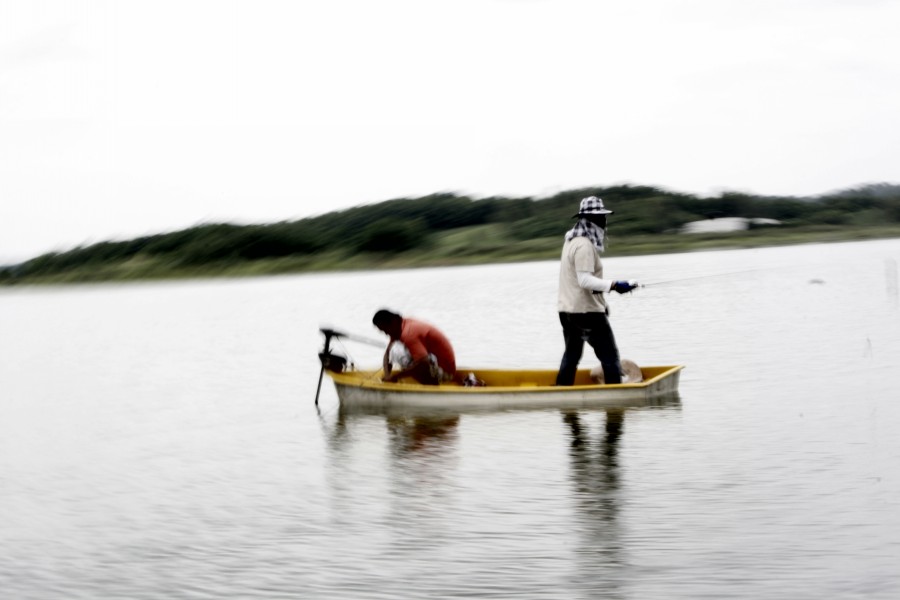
left=556, top=313, right=622, bottom=385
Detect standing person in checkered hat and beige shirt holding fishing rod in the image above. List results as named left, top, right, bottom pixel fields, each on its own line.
left=556, top=196, right=637, bottom=385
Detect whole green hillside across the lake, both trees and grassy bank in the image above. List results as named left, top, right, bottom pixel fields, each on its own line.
left=0, top=184, right=900, bottom=285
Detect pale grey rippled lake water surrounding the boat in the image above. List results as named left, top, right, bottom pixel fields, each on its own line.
left=0, top=240, right=900, bottom=600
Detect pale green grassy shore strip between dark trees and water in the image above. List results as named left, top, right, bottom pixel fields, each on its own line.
left=0, top=225, right=900, bottom=288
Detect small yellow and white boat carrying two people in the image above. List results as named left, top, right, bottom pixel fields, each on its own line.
left=329, top=365, right=683, bottom=410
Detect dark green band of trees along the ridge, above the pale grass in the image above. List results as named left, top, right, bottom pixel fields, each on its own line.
left=0, top=184, right=900, bottom=284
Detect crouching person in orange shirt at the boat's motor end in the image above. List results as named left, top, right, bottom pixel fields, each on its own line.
left=372, top=309, right=456, bottom=385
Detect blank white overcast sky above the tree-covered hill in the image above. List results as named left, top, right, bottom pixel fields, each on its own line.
left=0, top=0, right=900, bottom=264
